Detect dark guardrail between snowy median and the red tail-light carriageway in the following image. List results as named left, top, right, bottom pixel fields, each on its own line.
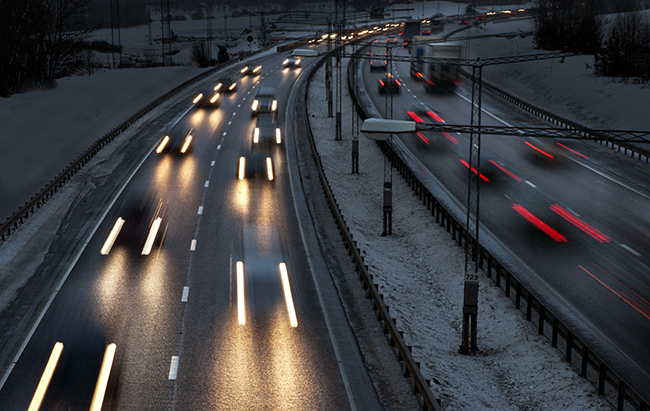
left=348, top=42, right=650, bottom=411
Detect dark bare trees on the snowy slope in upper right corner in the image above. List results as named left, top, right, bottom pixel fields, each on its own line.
left=531, top=0, right=650, bottom=81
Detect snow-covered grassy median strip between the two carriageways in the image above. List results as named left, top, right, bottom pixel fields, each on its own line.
left=308, top=58, right=610, bottom=410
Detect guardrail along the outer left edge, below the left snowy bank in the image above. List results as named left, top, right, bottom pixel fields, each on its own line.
left=0, top=50, right=264, bottom=245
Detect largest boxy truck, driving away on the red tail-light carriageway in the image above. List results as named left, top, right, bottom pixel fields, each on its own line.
left=411, top=43, right=462, bottom=91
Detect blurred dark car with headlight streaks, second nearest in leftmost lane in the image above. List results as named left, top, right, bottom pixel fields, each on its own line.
left=100, top=187, right=167, bottom=255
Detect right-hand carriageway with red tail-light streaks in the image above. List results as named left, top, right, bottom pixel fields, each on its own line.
left=362, top=38, right=650, bottom=381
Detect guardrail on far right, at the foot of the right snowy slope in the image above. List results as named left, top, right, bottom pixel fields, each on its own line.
left=460, top=69, right=650, bottom=163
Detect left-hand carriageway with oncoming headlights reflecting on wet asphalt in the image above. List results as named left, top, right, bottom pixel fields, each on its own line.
left=0, top=47, right=381, bottom=410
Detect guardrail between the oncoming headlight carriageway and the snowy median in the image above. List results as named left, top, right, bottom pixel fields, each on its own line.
left=299, top=43, right=441, bottom=411
